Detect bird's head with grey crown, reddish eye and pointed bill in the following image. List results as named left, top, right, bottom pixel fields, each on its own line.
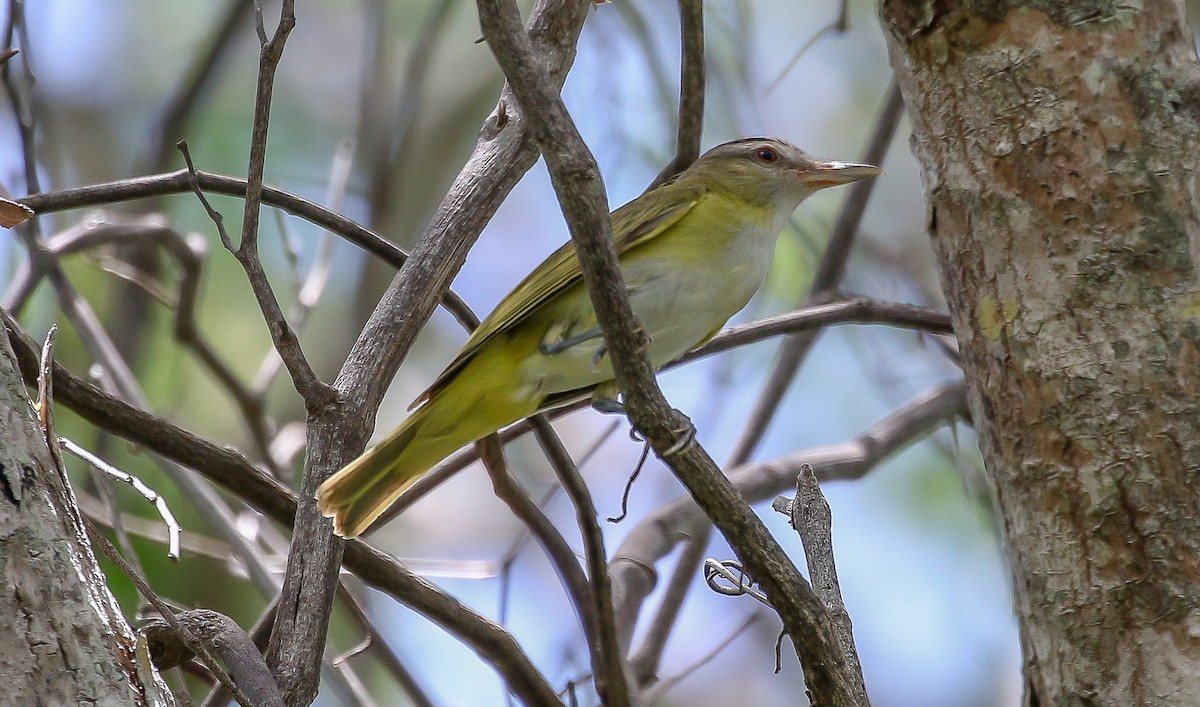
left=678, top=138, right=883, bottom=210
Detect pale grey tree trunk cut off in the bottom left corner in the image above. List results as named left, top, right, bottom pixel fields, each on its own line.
left=0, top=324, right=173, bottom=706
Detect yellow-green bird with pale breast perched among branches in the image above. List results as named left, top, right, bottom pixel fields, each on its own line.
left=317, top=138, right=881, bottom=538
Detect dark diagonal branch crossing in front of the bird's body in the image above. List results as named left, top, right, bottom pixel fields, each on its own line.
left=476, top=0, right=852, bottom=705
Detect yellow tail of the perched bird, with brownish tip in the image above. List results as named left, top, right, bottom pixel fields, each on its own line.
left=317, top=357, right=538, bottom=538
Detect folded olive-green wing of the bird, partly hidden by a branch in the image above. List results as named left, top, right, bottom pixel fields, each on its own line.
left=409, top=186, right=704, bottom=409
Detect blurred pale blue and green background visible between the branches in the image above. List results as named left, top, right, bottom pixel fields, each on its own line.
left=0, top=0, right=1020, bottom=707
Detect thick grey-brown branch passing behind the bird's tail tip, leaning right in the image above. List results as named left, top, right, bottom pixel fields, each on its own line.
left=276, top=0, right=588, bottom=694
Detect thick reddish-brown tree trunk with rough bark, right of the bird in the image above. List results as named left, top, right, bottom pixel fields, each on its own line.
left=881, top=0, right=1200, bottom=705
